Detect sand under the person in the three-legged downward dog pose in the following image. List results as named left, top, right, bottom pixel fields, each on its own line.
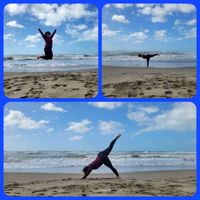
left=4, top=170, right=196, bottom=196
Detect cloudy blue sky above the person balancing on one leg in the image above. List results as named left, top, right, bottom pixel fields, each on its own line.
left=102, top=4, right=196, bottom=52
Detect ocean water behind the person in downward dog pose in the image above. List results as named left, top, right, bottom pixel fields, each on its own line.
left=4, top=151, right=196, bottom=173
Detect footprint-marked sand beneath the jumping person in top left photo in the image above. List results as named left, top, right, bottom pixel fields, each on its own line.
left=4, top=70, right=98, bottom=98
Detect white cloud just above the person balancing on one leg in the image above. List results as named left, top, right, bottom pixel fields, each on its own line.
left=121, top=29, right=149, bottom=43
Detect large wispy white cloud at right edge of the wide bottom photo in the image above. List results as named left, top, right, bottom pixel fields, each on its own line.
left=130, top=103, right=196, bottom=134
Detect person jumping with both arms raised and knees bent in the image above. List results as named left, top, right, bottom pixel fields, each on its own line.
left=37, top=29, right=56, bottom=60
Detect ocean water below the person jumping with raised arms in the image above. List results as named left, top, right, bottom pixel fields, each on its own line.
left=4, top=54, right=98, bottom=72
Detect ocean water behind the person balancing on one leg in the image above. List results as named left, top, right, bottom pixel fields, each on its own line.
left=103, top=51, right=196, bottom=68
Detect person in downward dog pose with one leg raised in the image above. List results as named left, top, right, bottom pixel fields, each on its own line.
left=82, top=134, right=121, bottom=179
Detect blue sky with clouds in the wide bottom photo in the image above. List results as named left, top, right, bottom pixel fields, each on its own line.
left=4, top=102, right=196, bottom=151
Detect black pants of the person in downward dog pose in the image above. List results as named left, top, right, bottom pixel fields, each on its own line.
left=98, top=138, right=119, bottom=176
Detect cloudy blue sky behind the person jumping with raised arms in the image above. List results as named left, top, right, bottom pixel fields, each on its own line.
left=4, top=4, right=98, bottom=54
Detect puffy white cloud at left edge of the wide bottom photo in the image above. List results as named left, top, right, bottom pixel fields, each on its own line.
left=4, top=110, right=49, bottom=130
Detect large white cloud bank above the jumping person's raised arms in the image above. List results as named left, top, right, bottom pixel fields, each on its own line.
left=5, top=4, right=97, bottom=27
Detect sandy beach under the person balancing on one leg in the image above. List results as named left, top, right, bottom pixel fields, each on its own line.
left=103, top=66, right=196, bottom=98
